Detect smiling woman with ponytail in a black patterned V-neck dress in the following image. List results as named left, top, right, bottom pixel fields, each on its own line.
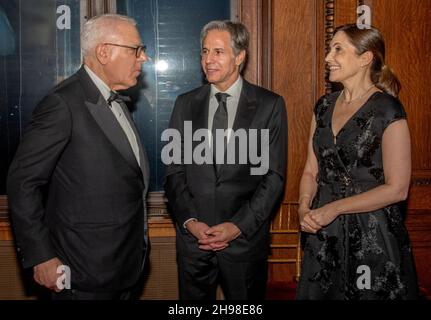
left=297, top=24, right=417, bottom=300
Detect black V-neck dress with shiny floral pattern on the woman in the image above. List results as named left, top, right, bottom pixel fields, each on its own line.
left=297, top=92, right=417, bottom=300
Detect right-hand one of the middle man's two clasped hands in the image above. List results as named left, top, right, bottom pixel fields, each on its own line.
left=199, top=222, right=241, bottom=250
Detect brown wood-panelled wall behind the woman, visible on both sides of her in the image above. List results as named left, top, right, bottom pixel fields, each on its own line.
left=269, top=0, right=431, bottom=295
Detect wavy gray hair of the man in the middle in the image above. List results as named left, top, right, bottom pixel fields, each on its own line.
left=201, top=20, right=250, bottom=72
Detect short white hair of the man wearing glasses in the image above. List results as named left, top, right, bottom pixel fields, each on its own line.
left=81, top=14, right=136, bottom=57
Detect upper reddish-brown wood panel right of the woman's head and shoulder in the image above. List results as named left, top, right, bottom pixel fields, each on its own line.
left=372, top=0, right=431, bottom=170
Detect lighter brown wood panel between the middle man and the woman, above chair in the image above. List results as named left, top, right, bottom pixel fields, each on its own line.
left=271, top=0, right=317, bottom=201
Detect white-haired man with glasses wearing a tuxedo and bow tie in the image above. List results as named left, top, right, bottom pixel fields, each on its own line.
left=8, top=15, right=149, bottom=300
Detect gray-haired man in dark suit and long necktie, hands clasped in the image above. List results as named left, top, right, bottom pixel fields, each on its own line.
left=165, top=21, right=287, bottom=300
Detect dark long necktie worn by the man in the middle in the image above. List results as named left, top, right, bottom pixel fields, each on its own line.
left=211, top=92, right=229, bottom=171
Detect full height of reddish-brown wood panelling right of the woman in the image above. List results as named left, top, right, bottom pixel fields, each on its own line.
left=371, top=0, right=431, bottom=295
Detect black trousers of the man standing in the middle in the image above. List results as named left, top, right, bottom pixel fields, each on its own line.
left=177, top=252, right=268, bottom=301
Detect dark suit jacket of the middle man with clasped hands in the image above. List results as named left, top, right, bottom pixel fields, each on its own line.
left=165, top=80, right=287, bottom=261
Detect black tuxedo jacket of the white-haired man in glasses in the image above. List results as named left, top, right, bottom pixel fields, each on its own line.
left=8, top=67, right=149, bottom=291
